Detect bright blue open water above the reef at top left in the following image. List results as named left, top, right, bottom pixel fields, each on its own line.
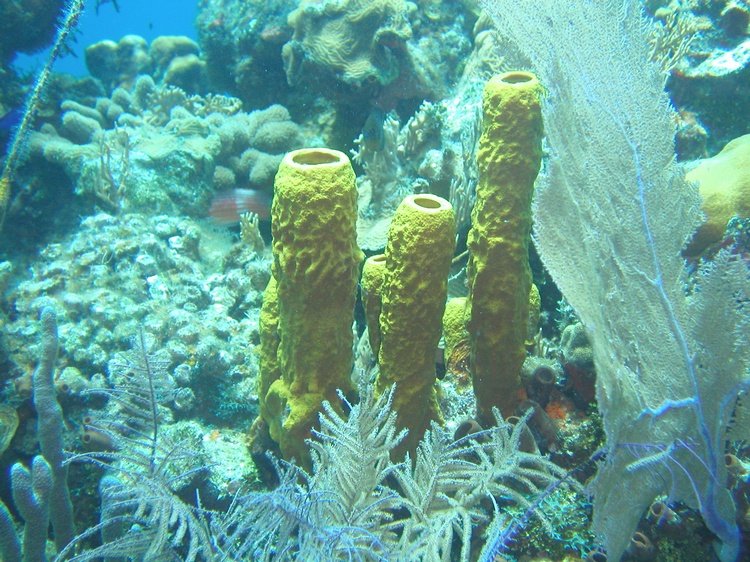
left=14, top=0, right=198, bottom=76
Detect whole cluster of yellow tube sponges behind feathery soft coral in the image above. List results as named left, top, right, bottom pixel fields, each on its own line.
left=259, top=72, right=543, bottom=466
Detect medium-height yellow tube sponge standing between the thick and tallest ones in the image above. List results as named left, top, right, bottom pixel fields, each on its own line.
left=376, top=194, right=456, bottom=456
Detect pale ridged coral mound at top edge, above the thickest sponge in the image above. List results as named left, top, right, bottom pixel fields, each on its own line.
left=282, top=0, right=411, bottom=85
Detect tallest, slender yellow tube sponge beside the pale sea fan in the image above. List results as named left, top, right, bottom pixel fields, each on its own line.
left=466, top=72, right=543, bottom=423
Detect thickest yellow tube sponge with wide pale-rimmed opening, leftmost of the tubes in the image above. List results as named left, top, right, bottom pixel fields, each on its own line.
left=265, top=148, right=363, bottom=468
